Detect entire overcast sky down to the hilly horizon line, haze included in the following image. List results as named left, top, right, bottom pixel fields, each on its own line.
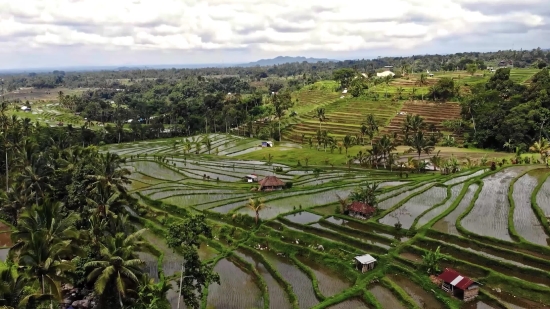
left=0, top=0, right=550, bottom=69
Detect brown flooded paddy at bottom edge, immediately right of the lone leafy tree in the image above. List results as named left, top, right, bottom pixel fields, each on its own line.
left=206, top=259, right=263, bottom=309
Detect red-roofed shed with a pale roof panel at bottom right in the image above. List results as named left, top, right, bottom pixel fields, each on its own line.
left=437, top=268, right=479, bottom=301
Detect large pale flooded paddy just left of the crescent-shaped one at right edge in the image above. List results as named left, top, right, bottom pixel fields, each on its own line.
left=462, top=166, right=526, bottom=241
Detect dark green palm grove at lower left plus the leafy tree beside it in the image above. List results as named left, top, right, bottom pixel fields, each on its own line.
left=0, top=103, right=218, bottom=309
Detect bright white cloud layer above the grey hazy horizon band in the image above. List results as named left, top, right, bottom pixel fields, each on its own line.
left=0, top=0, right=550, bottom=66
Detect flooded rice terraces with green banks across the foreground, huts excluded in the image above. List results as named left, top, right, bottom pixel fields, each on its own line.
left=99, top=134, right=550, bottom=309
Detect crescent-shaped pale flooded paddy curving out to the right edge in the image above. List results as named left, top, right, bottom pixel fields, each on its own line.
left=512, top=174, right=548, bottom=246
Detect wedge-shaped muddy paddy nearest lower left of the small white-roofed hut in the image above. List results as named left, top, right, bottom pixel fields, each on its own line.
left=298, top=257, right=351, bottom=297
